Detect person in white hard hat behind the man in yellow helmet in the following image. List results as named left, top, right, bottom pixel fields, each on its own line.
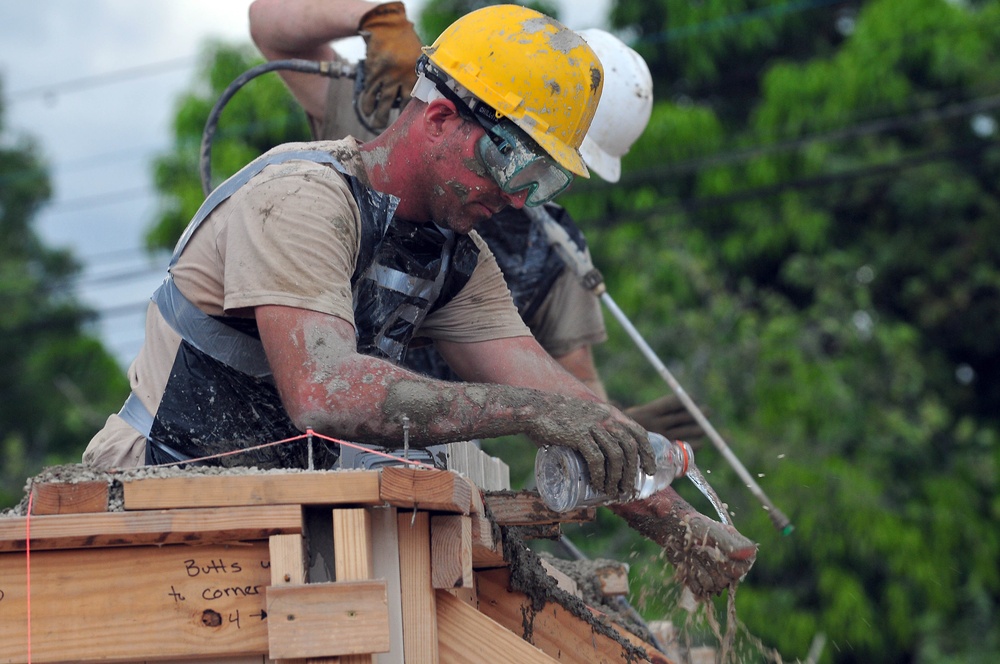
left=250, top=0, right=703, bottom=445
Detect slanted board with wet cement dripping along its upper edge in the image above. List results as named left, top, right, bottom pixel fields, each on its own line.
left=476, top=568, right=648, bottom=664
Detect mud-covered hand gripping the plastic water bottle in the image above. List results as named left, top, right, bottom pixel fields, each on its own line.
left=528, top=397, right=656, bottom=497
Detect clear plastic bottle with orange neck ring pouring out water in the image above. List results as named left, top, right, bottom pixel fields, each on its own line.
left=535, top=432, right=694, bottom=512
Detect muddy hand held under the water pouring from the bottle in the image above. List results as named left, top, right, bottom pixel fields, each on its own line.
left=610, top=487, right=757, bottom=599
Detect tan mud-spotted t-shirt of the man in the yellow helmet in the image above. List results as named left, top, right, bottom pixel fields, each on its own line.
left=84, top=138, right=530, bottom=467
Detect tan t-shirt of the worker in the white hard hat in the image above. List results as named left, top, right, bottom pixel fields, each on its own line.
left=310, top=78, right=608, bottom=358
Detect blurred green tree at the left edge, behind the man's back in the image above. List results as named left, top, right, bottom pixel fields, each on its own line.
left=0, top=81, right=128, bottom=507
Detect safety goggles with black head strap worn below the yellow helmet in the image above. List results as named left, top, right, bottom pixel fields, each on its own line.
left=413, top=55, right=573, bottom=207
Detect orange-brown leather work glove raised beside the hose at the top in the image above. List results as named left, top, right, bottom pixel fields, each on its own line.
left=358, top=2, right=421, bottom=131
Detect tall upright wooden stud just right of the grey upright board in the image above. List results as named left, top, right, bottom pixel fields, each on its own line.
left=396, top=511, right=439, bottom=664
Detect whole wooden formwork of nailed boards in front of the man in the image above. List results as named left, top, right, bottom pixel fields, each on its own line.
left=0, top=467, right=666, bottom=664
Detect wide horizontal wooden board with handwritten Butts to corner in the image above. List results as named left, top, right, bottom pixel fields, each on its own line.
left=0, top=541, right=270, bottom=663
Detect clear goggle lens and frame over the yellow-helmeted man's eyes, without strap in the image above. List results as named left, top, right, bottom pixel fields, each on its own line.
left=474, top=119, right=573, bottom=207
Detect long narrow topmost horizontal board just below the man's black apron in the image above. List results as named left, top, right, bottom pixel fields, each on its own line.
left=122, top=470, right=380, bottom=510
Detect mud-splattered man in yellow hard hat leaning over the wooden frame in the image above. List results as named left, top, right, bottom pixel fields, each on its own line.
left=84, top=5, right=655, bottom=495
